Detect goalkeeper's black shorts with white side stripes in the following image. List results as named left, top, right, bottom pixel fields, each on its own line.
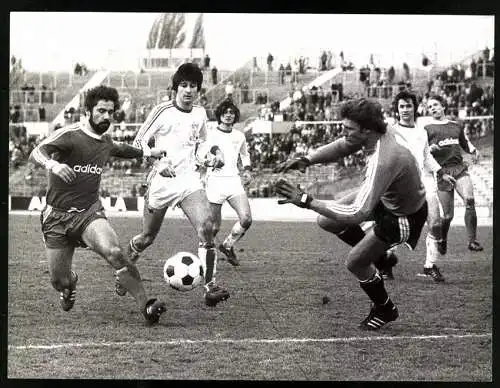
left=373, top=201, right=427, bottom=249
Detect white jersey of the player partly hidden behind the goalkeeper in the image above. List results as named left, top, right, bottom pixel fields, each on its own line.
left=392, top=123, right=441, bottom=177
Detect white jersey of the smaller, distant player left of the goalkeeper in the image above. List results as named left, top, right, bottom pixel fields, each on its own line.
left=207, top=127, right=250, bottom=176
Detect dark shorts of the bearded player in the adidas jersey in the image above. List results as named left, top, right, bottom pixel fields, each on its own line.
left=40, top=201, right=106, bottom=249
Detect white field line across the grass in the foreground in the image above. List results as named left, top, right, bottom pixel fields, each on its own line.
left=8, top=333, right=492, bottom=350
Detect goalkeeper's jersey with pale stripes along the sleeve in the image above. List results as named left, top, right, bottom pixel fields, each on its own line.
left=328, top=128, right=425, bottom=223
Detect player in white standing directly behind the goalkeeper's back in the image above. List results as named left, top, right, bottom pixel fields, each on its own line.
left=393, top=90, right=455, bottom=282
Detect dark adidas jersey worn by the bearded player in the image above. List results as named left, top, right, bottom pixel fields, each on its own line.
left=32, top=122, right=142, bottom=210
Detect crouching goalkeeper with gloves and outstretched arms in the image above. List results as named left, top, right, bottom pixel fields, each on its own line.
left=276, top=98, right=427, bottom=330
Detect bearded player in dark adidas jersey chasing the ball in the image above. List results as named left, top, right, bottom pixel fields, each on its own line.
left=30, top=86, right=166, bottom=324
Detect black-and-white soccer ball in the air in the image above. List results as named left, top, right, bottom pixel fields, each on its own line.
left=163, top=252, right=204, bottom=291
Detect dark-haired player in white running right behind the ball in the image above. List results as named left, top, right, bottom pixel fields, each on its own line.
left=116, top=63, right=229, bottom=306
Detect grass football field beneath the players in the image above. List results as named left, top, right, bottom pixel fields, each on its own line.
left=7, top=213, right=493, bottom=382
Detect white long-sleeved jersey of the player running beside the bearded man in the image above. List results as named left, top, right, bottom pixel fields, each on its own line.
left=133, top=101, right=207, bottom=176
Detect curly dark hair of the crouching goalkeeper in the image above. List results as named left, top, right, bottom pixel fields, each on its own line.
left=340, top=98, right=387, bottom=133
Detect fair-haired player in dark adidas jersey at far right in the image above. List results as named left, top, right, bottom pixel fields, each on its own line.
left=424, top=96, right=483, bottom=254
